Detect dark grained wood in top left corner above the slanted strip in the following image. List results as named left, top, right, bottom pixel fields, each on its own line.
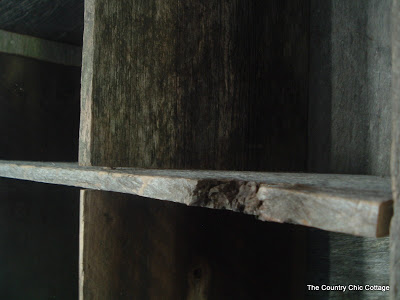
left=0, top=0, right=84, bottom=46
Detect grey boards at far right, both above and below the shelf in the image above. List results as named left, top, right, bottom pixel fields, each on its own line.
left=307, top=0, right=392, bottom=300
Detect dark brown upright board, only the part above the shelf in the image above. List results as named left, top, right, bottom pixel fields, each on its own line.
left=80, top=0, right=309, bottom=171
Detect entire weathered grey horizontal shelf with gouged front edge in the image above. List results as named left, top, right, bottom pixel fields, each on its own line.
left=0, top=161, right=393, bottom=237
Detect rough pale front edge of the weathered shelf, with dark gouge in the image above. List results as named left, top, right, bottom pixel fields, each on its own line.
left=0, top=163, right=391, bottom=237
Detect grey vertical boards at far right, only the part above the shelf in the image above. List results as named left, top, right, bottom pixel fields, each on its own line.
left=308, top=0, right=392, bottom=176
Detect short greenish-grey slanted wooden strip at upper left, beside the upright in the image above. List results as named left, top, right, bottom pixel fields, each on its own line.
left=0, top=30, right=82, bottom=67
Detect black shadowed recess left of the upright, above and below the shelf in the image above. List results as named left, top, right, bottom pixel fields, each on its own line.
left=0, top=52, right=80, bottom=300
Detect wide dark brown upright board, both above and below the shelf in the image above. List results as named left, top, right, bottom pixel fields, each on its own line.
left=79, top=0, right=309, bottom=300
